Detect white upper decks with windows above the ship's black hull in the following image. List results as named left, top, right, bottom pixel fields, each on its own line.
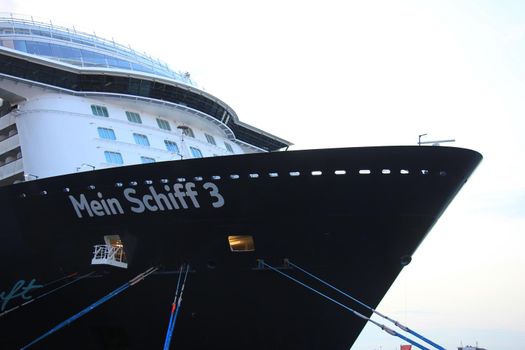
left=0, top=17, right=289, bottom=185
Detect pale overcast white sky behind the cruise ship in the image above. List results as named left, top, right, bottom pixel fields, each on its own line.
left=0, top=0, right=525, bottom=350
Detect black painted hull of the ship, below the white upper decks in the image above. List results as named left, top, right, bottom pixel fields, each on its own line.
left=0, top=147, right=481, bottom=349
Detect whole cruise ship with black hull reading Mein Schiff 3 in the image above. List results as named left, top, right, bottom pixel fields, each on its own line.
left=0, top=15, right=482, bottom=350
